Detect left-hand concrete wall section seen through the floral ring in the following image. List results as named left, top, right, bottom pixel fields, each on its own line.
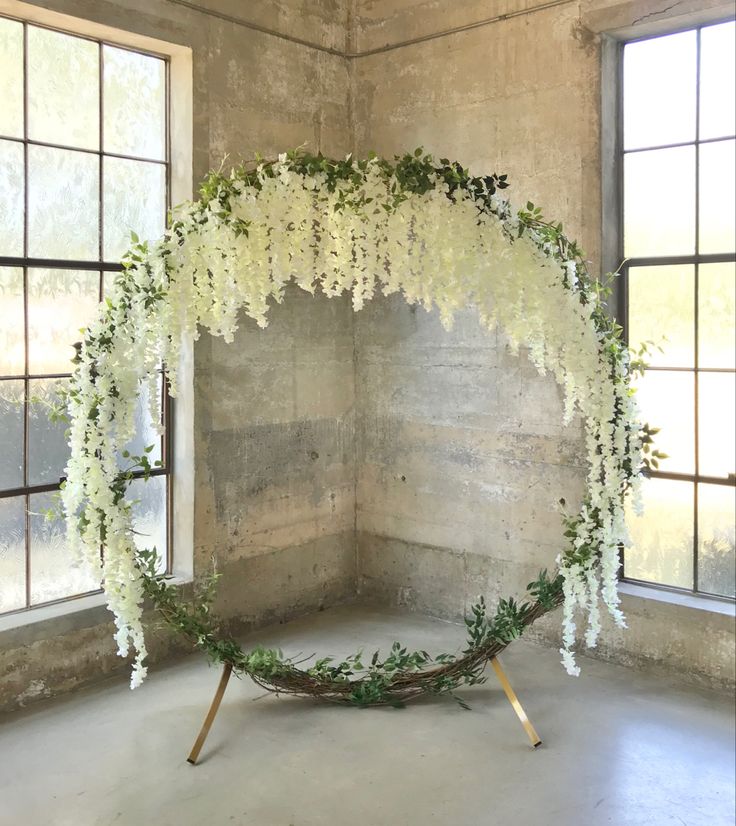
left=195, top=285, right=355, bottom=621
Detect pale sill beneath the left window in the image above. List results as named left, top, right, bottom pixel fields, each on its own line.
left=0, top=576, right=191, bottom=651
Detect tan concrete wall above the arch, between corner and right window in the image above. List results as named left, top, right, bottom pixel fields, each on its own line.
left=353, top=0, right=600, bottom=258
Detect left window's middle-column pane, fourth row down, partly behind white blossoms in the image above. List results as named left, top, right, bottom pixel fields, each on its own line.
left=28, top=379, right=69, bottom=485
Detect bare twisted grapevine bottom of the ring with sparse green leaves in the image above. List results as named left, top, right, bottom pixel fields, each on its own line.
left=141, top=552, right=563, bottom=706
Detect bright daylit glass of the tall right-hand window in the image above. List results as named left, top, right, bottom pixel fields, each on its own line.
left=621, top=21, right=736, bottom=597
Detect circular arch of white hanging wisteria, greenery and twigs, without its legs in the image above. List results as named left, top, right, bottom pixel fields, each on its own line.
left=62, top=150, right=649, bottom=705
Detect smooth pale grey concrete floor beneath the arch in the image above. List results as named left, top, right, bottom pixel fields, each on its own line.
left=0, top=607, right=734, bottom=826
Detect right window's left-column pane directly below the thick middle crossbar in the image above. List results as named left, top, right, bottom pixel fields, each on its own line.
left=628, top=265, right=695, bottom=367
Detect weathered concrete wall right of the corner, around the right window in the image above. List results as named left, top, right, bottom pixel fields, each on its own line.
left=351, top=0, right=734, bottom=684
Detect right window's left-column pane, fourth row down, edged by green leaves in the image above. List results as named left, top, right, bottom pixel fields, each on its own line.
left=636, top=370, right=695, bottom=473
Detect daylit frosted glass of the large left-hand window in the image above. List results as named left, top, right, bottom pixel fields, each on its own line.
left=0, top=17, right=171, bottom=612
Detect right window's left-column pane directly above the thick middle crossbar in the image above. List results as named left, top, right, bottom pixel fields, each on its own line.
left=624, top=146, right=695, bottom=257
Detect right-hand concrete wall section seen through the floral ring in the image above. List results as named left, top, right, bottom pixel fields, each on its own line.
left=356, top=296, right=584, bottom=617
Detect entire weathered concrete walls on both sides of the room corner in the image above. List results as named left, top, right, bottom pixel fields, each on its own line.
left=0, top=0, right=734, bottom=708
